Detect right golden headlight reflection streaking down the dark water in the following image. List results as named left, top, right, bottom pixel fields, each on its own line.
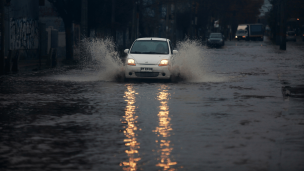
left=153, top=85, right=177, bottom=171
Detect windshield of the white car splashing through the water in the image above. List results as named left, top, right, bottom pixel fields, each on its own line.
left=130, top=40, right=169, bottom=54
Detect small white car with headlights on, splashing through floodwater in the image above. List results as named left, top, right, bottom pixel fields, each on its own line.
left=124, top=37, right=178, bottom=79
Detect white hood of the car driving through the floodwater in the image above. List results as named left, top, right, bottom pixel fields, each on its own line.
left=128, top=54, right=170, bottom=64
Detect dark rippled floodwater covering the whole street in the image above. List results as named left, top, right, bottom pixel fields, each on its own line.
left=0, top=41, right=304, bottom=171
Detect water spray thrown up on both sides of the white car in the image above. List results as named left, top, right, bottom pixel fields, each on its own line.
left=55, top=38, right=225, bottom=82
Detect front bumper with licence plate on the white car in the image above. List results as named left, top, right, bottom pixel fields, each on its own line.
left=125, top=64, right=171, bottom=79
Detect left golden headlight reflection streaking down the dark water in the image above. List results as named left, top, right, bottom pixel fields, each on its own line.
left=120, top=85, right=141, bottom=171
